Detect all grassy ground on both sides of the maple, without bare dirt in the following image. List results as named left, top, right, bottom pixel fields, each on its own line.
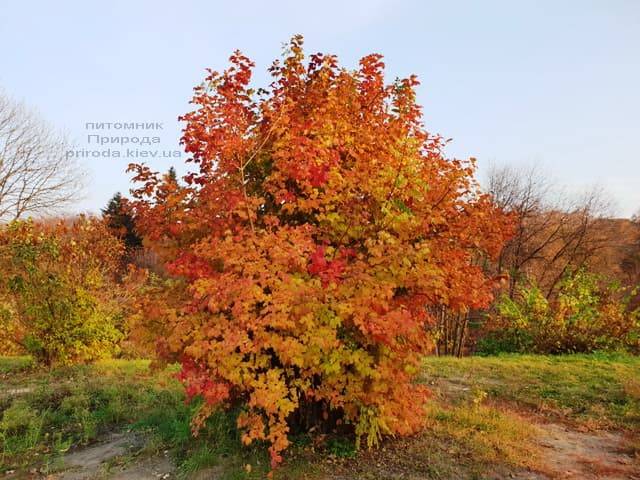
left=0, top=355, right=640, bottom=479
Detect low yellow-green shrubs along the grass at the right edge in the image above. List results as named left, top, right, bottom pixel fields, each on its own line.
left=479, top=269, right=640, bottom=353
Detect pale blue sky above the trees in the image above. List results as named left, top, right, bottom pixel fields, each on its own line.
left=0, top=0, right=640, bottom=216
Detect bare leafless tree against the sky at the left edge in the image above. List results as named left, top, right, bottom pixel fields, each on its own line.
left=0, top=92, right=84, bottom=221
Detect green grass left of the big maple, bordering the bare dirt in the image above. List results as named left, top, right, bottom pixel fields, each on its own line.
left=0, top=357, right=268, bottom=479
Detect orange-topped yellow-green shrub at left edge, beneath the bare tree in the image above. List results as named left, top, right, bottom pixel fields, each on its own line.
left=0, top=217, right=123, bottom=365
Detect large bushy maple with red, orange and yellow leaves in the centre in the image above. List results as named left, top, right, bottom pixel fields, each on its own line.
left=130, top=37, right=510, bottom=465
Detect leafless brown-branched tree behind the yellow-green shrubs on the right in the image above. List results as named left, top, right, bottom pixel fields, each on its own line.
left=488, top=166, right=614, bottom=298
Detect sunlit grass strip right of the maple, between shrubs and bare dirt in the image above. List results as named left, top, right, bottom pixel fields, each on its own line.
left=423, top=354, right=640, bottom=431
